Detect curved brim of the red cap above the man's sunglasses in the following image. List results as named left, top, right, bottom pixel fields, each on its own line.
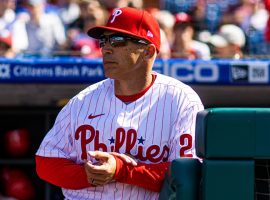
left=87, top=26, right=147, bottom=40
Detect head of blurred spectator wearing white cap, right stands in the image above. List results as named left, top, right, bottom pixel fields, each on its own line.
left=209, top=24, right=246, bottom=59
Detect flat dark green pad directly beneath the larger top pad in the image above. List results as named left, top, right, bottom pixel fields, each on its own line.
left=201, top=160, right=254, bottom=200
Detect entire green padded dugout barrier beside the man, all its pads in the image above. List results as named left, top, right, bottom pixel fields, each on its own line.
left=159, top=108, right=270, bottom=200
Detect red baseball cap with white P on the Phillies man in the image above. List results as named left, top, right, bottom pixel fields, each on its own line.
left=87, top=7, right=160, bottom=52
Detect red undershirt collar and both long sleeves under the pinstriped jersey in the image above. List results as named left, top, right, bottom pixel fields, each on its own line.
left=36, top=74, right=170, bottom=192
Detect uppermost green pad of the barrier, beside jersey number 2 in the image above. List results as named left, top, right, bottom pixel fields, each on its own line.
left=195, top=108, right=270, bottom=158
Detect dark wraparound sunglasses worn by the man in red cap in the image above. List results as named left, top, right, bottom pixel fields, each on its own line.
left=99, top=34, right=149, bottom=48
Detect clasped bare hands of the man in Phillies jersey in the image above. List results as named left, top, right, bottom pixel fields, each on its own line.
left=84, top=151, right=137, bottom=186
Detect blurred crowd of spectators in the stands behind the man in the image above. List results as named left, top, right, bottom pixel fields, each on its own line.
left=0, top=0, right=270, bottom=59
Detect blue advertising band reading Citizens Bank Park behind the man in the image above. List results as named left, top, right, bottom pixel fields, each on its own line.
left=0, top=58, right=270, bottom=85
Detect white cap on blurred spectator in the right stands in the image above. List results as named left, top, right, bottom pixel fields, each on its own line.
left=209, top=24, right=246, bottom=47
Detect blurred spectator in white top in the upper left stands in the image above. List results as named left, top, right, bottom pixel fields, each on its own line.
left=13, top=0, right=66, bottom=56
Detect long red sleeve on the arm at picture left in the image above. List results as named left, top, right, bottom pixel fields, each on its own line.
left=36, top=156, right=91, bottom=190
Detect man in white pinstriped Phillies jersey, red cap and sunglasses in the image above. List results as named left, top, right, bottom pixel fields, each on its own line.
left=36, top=8, right=203, bottom=199
